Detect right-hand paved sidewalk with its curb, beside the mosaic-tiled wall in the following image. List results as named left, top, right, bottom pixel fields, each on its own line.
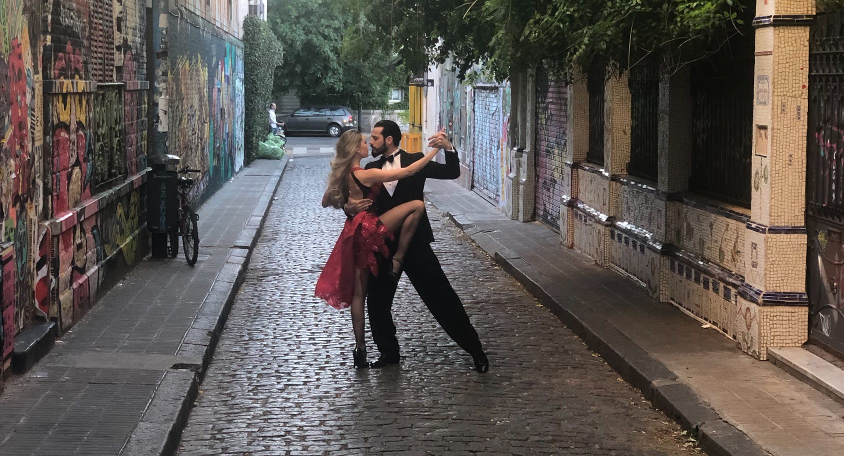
left=426, top=179, right=844, bottom=456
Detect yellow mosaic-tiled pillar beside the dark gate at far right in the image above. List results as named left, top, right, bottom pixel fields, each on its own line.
left=733, top=0, right=815, bottom=360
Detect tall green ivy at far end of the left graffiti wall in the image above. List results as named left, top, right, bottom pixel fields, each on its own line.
left=243, top=16, right=283, bottom=163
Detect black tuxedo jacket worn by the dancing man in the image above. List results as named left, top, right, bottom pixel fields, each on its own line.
left=366, top=150, right=460, bottom=243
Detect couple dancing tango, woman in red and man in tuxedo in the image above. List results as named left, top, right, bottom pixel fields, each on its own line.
left=315, top=120, right=489, bottom=373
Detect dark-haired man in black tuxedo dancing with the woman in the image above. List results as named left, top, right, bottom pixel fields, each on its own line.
left=344, top=120, right=489, bottom=373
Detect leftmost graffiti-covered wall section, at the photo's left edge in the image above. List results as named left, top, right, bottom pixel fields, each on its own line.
left=0, top=0, right=44, bottom=363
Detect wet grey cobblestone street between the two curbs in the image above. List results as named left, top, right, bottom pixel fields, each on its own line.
left=179, top=156, right=700, bottom=456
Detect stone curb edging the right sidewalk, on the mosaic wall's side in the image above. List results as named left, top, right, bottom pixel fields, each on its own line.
left=445, top=211, right=770, bottom=456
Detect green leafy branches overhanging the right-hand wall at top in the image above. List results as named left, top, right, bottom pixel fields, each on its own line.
left=352, top=0, right=753, bottom=79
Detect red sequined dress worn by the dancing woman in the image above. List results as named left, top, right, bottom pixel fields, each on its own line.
left=314, top=167, right=393, bottom=309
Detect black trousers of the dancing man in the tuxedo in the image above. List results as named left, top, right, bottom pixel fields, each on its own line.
left=367, top=242, right=482, bottom=357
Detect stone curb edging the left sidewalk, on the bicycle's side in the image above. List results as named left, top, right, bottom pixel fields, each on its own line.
left=119, top=155, right=289, bottom=456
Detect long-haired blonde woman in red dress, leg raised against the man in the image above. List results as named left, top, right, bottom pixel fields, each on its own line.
left=315, top=130, right=437, bottom=368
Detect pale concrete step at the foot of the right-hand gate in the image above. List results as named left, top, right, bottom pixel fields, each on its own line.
left=768, top=347, right=844, bottom=404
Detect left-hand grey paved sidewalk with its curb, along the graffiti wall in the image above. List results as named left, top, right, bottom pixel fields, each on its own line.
left=0, top=157, right=287, bottom=456
